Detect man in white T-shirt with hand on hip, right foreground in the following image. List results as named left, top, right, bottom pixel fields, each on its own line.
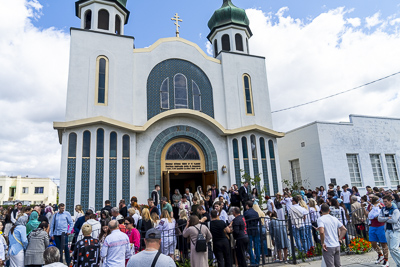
left=317, top=204, right=347, bottom=267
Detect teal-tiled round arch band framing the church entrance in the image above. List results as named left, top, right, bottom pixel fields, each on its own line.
left=148, top=125, right=218, bottom=197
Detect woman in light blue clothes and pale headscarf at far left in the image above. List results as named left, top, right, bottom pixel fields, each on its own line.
left=8, top=217, right=28, bottom=267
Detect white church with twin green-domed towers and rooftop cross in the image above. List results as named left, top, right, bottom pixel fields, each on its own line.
left=54, top=0, right=284, bottom=214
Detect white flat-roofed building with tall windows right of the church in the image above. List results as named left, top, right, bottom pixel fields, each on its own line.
left=278, top=115, right=400, bottom=193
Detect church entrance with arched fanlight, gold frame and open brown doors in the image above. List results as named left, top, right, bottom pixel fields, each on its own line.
left=161, top=138, right=218, bottom=201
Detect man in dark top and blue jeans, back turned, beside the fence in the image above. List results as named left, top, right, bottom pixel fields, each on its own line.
left=244, top=200, right=261, bottom=264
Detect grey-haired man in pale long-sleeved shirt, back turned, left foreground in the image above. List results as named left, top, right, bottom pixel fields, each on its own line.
left=100, top=220, right=132, bottom=267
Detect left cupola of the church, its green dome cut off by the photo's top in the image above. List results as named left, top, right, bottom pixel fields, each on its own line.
left=75, top=0, right=129, bottom=35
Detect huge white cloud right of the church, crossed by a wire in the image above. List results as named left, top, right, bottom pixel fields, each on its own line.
left=247, top=8, right=400, bottom=131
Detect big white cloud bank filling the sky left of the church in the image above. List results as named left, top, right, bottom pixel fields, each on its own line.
left=0, top=0, right=69, bottom=180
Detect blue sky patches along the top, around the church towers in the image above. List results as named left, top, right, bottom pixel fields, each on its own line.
left=33, top=0, right=400, bottom=49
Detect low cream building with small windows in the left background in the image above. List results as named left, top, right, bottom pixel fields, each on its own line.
left=0, top=176, right=57, bottom=205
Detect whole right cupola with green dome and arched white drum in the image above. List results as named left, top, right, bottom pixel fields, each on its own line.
left=207, top=0, right=253, bottom=57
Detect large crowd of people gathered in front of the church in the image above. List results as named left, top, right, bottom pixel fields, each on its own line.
left=0, top=182, right=400, bottom=267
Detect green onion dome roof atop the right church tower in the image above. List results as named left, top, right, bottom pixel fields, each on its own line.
left=208, top=0, right=251, bottom=35
